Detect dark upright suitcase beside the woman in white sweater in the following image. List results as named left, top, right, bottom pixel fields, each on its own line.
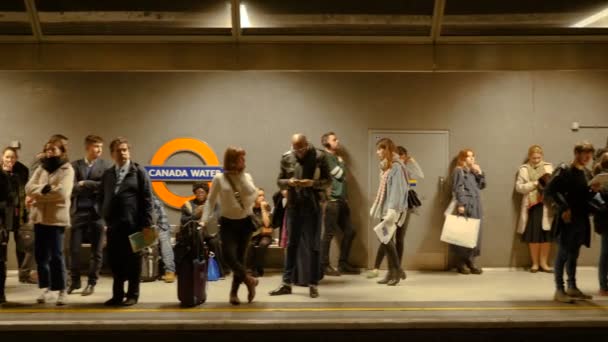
left=175, top=221, right=209, bottom=307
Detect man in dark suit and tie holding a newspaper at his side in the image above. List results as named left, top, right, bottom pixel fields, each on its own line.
left=98, top=137, right=153, bottom=306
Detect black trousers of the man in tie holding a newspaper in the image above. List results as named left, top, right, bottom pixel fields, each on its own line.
left=107, top=226, right=142, bottom=301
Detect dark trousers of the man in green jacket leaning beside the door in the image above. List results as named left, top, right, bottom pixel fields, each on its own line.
left=321, top=200, right=355, bottom=267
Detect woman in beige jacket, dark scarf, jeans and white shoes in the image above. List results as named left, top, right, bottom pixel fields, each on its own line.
left=25, top=139, right=74, bottom=305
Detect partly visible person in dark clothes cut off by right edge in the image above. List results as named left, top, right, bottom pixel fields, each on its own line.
left=593, top=151, right=608, bottom=297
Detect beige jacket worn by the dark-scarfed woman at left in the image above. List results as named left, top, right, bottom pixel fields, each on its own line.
left=25, top=163, right=74, bottom=227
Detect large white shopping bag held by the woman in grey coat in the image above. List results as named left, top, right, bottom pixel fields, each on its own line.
left=440, top=215, right=481, bottom=248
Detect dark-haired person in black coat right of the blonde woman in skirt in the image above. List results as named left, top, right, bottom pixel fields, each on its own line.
left=545, top=143, right=599, bottom=303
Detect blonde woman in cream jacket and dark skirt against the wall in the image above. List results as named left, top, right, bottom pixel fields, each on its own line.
left=515, top=145, right=553, bottom=273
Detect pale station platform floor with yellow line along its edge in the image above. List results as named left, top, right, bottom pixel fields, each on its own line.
left=0, top=268, right=608, bottom=341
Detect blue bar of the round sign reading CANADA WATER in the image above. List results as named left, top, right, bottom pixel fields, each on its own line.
left=144, top=166, right=223, bottom=182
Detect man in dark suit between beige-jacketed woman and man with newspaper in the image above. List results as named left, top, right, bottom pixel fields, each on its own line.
left=67, top=135, right=112, bottom=296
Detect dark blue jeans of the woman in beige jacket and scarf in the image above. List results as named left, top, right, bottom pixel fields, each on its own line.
left=34, top=224, right=66, bottom=291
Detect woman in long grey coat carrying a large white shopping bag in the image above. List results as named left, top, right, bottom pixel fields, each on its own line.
left=452, top=149, right=486, bottom=274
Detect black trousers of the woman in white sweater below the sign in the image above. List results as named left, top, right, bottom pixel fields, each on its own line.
left=220, top=217, right=253, bottom=291
